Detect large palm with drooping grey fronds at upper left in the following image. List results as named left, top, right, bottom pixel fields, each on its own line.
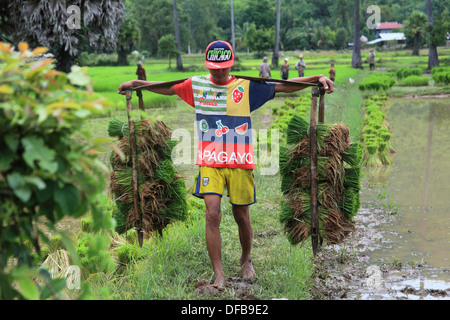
left=3, top=0, right=125, bottom=72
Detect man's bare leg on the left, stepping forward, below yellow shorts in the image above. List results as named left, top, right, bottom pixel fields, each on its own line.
left=204, top=194, right=225, bottom=288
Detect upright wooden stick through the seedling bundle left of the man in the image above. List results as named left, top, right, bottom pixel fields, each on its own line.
left=126, top=90, right=144, bottom=247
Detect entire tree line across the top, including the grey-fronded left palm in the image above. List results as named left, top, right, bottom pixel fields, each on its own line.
left=0, top=0, right=450, bottom=70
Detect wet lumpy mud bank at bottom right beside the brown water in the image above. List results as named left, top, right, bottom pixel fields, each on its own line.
left=312, top=204, right=450, bottom=300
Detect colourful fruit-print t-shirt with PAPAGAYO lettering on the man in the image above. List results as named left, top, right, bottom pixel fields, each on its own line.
left=175, top=75, right=275, bottom=169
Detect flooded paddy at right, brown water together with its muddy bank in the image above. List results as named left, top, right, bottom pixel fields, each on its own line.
left=319, top=98, right=450, bottom=300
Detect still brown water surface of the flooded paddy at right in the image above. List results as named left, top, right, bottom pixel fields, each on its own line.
left=362, top=99, right=450, bottom=281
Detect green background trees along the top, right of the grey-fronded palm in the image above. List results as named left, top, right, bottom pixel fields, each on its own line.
left=127, top=0, right=450, bottom=54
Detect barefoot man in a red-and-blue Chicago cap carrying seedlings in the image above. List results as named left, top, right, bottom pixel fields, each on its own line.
left=118, top=41, right=334, bottom=289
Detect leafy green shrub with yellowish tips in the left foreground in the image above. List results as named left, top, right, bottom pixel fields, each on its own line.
left=0, top=42, right=113, bottom=299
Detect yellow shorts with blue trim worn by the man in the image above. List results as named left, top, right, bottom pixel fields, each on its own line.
left=192, top=166, right=256, bottom=206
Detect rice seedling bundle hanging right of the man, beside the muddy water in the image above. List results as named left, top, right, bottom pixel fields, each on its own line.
left=279, top=115, right=362, bottom=244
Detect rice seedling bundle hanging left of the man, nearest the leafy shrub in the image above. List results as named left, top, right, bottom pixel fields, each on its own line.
left=108, top=119, right=187, bottom=233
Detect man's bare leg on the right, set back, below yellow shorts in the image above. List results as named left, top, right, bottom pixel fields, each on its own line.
left=233, top=205, right=256, bottom=279
